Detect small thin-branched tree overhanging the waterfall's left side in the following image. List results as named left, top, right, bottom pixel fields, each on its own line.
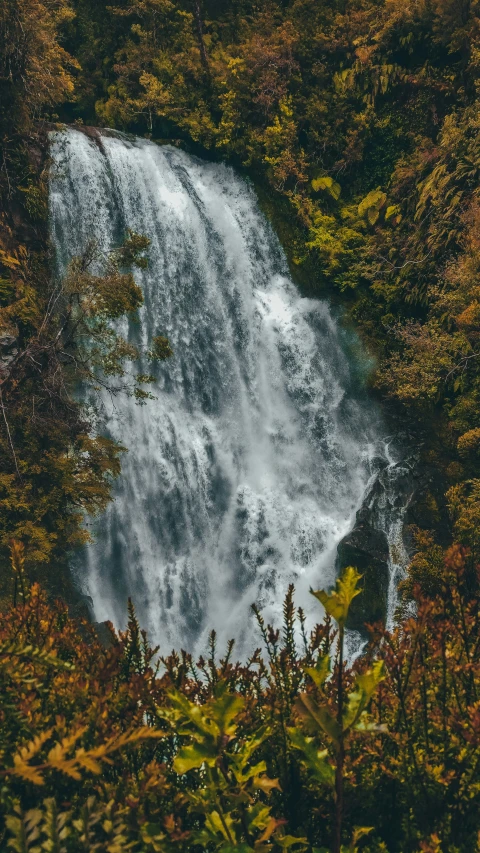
left=0, top=232, right=172, bottom=597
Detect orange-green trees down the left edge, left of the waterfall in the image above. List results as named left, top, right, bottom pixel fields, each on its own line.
left=0, top=0, right=171, bottom=600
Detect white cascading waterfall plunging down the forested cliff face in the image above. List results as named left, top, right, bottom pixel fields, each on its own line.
left=50, top=129, right=404, bottom=650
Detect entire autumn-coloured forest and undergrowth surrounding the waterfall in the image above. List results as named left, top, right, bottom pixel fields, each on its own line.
left=0, top=0, right=480, bottom=853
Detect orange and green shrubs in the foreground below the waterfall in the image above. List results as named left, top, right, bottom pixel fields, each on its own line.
left=0, top=556, right=480, bottom=853
